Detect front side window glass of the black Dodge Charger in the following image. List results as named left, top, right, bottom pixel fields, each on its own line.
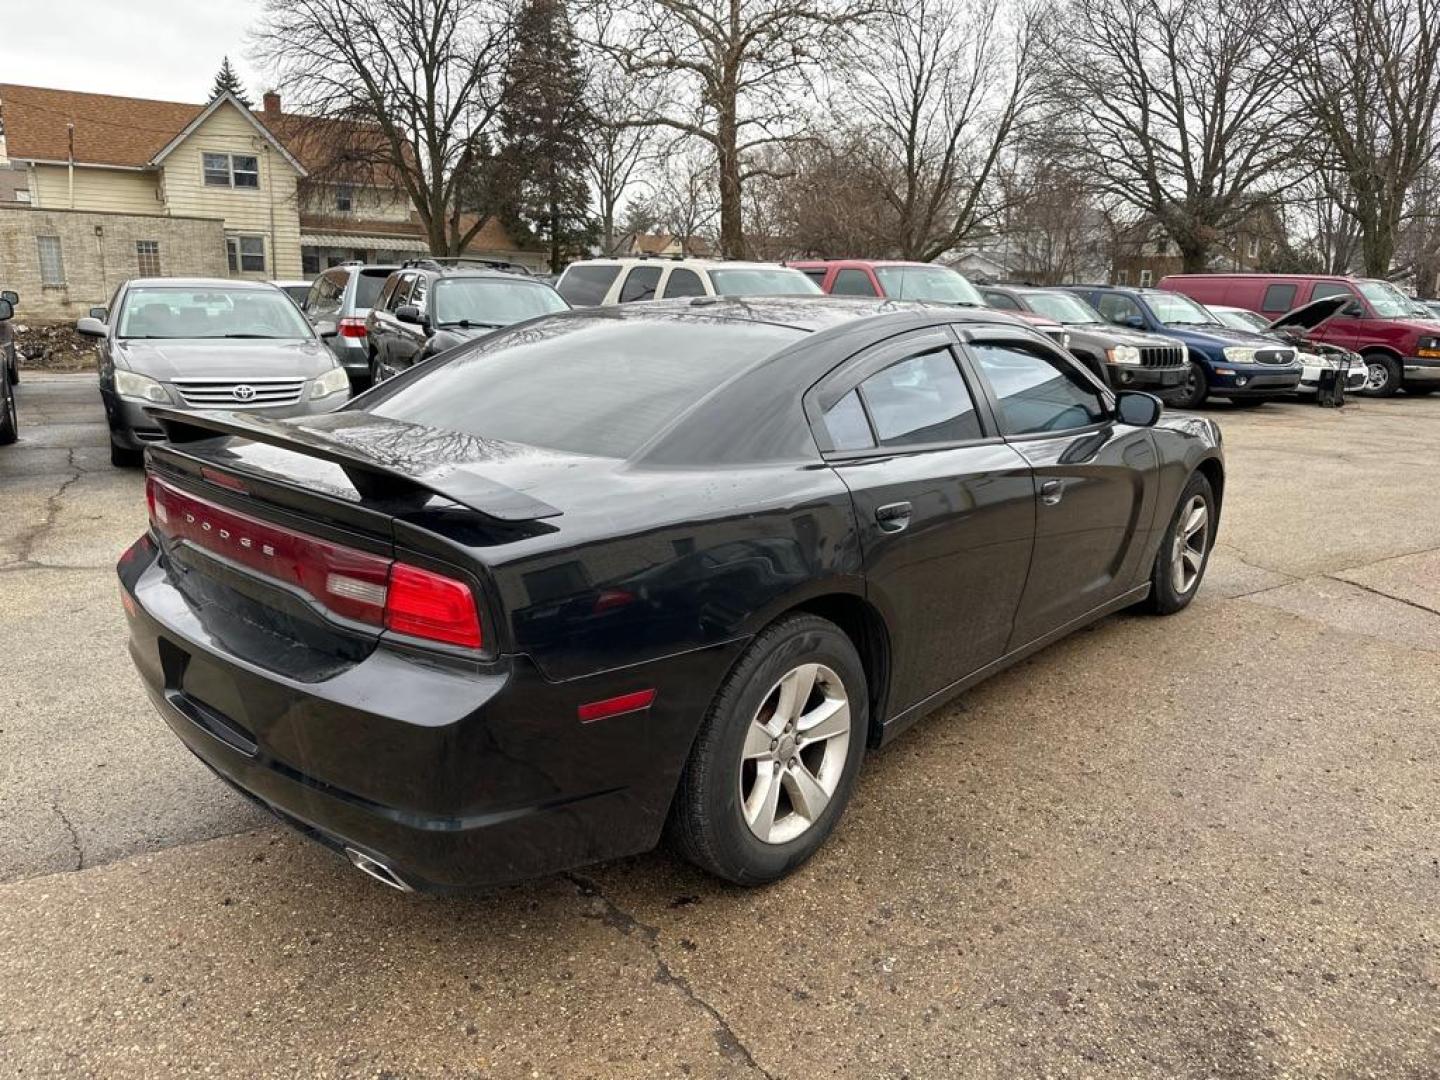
left=975, top=343, right=1104, bottom=435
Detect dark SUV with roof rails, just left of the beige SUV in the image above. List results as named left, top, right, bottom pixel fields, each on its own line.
left=366, top=259, right=570, bottom=383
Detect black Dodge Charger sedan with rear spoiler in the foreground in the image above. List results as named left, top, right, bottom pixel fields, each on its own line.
left=120, top=298, right=1224, bottom=888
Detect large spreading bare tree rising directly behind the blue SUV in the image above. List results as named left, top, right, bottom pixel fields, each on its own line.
left=1045, top=0, right=1301, bottom=271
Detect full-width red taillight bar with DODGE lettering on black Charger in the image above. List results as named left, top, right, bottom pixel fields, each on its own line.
left=145, top=477, right=482, bottom=648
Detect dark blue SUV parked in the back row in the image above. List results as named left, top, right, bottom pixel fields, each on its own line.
left=1067, top=285, right=1300, bottom=409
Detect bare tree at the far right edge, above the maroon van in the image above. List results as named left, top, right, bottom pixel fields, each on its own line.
left=1283, top=0, right=1440, bottom=278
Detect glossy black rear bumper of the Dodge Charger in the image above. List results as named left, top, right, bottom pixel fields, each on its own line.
left=118, top=537, right=740, bottom=890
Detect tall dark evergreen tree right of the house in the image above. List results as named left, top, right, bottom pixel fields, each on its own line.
left=500, top=0, right=596, bottom=271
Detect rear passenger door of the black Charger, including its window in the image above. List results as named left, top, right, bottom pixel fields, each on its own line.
left=806, top=325, right=1035, bottom=714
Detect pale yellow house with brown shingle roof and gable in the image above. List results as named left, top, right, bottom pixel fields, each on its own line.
left=0, top=85, right=307, bottom=284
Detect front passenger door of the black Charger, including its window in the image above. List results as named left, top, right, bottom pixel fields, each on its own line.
left=963, top=328, right=1159, bottom=649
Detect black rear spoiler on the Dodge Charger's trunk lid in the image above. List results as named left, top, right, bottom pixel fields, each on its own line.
left=145, top=406, right=560, bottom=521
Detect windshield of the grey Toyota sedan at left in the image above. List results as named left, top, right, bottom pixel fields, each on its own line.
left=118, top=285, right=314, bottom=338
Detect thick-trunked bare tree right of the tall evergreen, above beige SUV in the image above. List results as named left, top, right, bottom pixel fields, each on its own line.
left=609, top=0, right=873, bottom=258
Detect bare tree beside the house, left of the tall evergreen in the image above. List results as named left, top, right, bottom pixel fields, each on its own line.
left=253, top=0, right=507, bottom=255
